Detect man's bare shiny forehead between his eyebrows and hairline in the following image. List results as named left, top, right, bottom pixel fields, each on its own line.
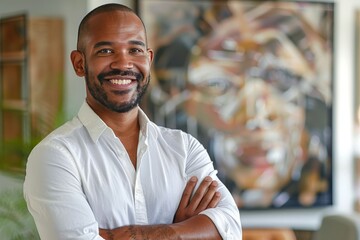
left=82, top=11, right=146, bottom=45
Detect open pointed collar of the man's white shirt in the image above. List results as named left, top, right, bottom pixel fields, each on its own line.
left=78, top=101, right=150, bottom=142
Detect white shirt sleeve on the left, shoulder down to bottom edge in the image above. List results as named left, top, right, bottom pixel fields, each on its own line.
left=24, top=143, right=103, bottom=240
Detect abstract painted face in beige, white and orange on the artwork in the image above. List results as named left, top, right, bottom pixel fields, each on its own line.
left=185, top=2, right=330, bottom=206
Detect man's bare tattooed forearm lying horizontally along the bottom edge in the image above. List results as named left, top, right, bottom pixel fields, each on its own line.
left=100, top=215, right=221, bottom=240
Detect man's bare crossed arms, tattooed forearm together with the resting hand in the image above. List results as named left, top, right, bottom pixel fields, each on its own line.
left=100, top=177, right=221, bottom=240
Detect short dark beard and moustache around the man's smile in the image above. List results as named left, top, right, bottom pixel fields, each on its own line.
left=85, top=66, right=150, bottom=113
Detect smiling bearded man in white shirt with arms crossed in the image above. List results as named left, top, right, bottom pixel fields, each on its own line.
left=24, top=4, right=241, bottom=240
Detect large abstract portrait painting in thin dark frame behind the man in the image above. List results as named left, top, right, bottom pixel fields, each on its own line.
left=137, top=0, right=335, bottom=209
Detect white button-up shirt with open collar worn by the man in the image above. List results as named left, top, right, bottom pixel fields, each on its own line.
left=24, top=103, right=241, bottom=240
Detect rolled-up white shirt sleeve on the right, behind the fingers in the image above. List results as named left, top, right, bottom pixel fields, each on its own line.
left=186, top=135, right=242, bottom=240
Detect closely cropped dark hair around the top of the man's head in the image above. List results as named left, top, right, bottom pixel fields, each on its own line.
left=77, top=3, right=146, bottom=51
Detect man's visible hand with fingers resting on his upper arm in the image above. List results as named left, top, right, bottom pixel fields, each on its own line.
left=173, top=176, right=221, bottom=223
